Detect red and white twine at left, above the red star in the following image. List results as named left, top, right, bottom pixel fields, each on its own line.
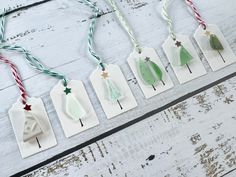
left=0, top=55, right=27, bottom=105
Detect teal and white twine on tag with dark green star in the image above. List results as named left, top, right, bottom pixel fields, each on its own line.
left=0, top=10, right=67, bottom=86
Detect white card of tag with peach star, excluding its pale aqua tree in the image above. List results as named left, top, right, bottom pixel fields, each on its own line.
left=90, top=64, right=137, bottom=119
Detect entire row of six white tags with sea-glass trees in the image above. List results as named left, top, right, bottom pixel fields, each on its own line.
left=9, top=25, right=236, bottom=158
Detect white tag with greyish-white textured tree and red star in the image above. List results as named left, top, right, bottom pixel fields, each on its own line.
left=9, top=98, right=57, bottom=158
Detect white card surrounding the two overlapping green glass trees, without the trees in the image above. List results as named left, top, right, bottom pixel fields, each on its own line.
left=128, top=47, right=174, bottom=98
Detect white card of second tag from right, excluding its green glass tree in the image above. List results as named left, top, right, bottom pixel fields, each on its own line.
left=162, top=35, right=206, bottom=84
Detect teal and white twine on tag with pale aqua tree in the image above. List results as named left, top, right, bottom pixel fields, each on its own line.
left=78, top=0, right=105, bottom=71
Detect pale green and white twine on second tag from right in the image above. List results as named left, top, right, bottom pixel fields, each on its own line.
left=161, top=0, right=176, bottom=41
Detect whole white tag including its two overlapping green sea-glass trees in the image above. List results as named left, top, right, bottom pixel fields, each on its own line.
left=128, top=48, right=174, bottom=98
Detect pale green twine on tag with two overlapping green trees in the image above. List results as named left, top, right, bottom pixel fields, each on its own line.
left=107, top=0, right=141, bottom=53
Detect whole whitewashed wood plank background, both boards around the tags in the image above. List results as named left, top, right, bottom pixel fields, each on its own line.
left=0, top=0, right=236, bottom=177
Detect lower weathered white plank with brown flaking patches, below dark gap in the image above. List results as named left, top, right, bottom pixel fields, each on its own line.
left=18, top=73, right=236, bottom=177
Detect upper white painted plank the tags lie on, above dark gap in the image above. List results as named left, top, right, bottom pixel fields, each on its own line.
left=0, top=0, right=236, bottom=175
